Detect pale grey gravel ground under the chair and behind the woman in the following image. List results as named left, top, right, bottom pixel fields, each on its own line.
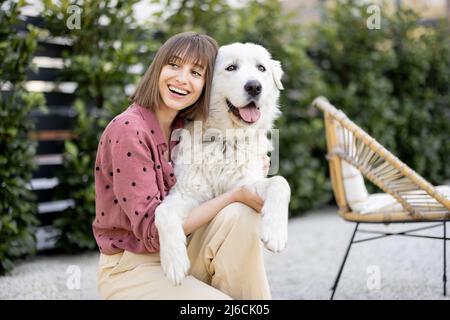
left=0, top=208, right=450, bottom=300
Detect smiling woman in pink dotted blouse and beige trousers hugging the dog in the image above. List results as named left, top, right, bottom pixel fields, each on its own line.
left=93, top=32, right=270, bottom=299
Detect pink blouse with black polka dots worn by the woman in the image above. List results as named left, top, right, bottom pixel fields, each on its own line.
left=92, top=104, right=184, bottom=255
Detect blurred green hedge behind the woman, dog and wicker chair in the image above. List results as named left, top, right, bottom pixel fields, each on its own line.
left=1, top=0, right=450, bottom=258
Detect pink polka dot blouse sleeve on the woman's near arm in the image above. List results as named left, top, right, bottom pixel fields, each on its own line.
left=110, top=122, right=161, bottom=252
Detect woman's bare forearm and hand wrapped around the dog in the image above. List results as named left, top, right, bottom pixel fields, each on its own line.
left=183, top=187, right=264, bottom=235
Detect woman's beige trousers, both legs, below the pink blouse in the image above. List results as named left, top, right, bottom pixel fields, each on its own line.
left=98, top=202, right=271, bottom=300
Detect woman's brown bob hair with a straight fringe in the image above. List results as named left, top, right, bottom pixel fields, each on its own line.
left=130, top=32, right=219, bottom=120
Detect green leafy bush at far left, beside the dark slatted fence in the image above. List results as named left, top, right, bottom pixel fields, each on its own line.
left=0, top=1, right=44, bottom=275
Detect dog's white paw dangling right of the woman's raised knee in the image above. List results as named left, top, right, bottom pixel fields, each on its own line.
left=261, top=205, right=288, bottom=253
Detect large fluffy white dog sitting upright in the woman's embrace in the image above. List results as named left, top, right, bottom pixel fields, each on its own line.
left=155, top=43, right=290, bottom=285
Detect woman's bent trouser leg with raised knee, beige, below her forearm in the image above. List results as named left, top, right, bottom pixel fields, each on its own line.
left=188, top=202, right=271, bottom=300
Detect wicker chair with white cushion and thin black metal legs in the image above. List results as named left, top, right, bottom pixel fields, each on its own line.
left=313, top=97, right=450, bottom=299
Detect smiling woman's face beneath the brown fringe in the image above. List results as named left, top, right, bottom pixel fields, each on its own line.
left=159, top=57, right=205, bottom=111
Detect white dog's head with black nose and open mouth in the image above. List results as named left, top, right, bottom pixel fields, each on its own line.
left=209, top=43, right=283, bottom=129
